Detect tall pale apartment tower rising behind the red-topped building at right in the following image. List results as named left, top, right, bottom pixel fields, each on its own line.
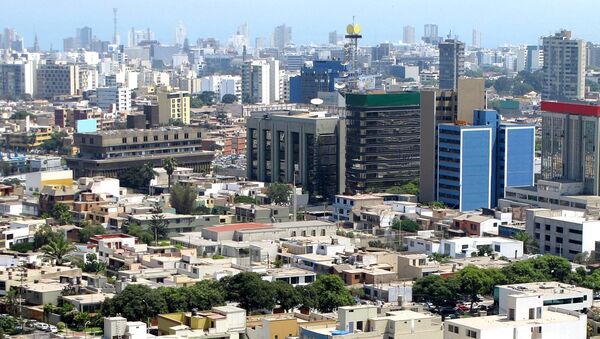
left=542, top=30, right=586, bottom=101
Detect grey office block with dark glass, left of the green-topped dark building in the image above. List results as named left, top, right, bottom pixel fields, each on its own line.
left=246, top=111, right=345, bottom=199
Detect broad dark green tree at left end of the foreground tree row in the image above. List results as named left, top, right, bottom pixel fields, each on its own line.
left=101, top=284, right=168, bottom=322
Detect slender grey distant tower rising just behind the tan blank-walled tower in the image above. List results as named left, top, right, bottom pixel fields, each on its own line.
left=438, top=39, right=465, bottom=90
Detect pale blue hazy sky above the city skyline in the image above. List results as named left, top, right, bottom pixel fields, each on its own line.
left=0, top=0, right=600, bottom=49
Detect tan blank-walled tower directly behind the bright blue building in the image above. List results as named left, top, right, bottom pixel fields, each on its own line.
left=419, top=78, right=486, bottom=202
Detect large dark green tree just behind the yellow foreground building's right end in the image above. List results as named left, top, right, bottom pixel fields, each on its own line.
left=221, top=272, right=275, bottom=313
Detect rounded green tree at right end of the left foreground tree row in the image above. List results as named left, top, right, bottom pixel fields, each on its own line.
left=304, top=274, right=355, bottom=313
